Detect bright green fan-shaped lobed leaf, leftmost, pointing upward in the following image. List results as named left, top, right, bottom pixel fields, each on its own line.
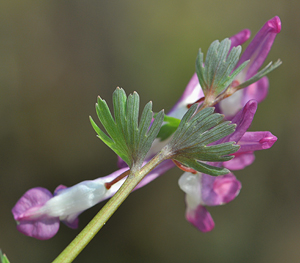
left=90, top=88, right=164, bottom=168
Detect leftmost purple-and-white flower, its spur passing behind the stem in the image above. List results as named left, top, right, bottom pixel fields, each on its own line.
left=12, top=161, right=175, bottom=240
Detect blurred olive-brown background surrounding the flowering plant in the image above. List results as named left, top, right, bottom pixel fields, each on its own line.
left=0, top=0, right=300, bottom=263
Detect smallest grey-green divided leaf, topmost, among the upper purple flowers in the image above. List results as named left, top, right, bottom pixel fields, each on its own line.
left=196, top=38, right=281, bottom=107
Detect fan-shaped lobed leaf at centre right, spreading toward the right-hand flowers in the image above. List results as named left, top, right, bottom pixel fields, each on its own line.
left=165, top=104, right=239, bottom=175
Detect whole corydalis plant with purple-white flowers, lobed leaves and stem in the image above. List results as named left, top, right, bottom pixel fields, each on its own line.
left=12, top=17, right=281, bottom=262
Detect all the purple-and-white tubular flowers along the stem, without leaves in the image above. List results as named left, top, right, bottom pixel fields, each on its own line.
left=12, top=17, right=281, bottom=240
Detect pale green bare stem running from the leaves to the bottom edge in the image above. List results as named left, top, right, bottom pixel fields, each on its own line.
left=53, top=152, right=165, bottom=263
